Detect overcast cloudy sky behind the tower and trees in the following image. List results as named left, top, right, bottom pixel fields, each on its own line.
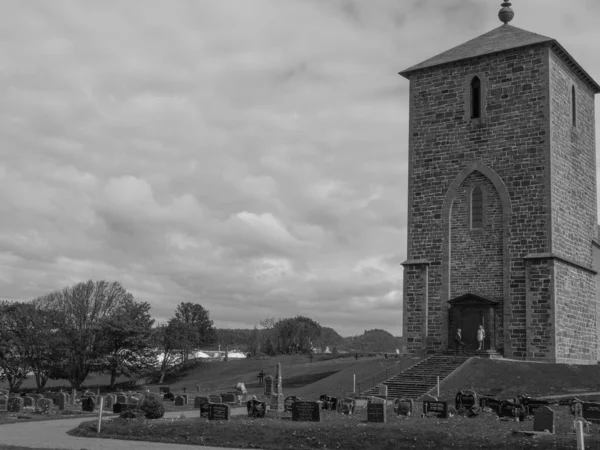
left=0, top=0, right=600, bottom=336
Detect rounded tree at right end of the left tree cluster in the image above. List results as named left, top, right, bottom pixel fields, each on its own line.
left=174, top=302, right=216, bottom=361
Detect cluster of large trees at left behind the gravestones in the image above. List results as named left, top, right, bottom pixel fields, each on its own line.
left=0, top=280, right=216, bottom=391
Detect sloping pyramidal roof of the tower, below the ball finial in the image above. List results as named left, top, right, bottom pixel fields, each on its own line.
left=400, top=24, right=600, bottom=93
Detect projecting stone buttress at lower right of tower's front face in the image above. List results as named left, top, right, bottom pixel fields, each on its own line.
left=527, top=259, right=556, bottom=362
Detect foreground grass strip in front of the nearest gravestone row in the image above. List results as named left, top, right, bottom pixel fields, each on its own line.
left=69, top=405, right=600, bottom=450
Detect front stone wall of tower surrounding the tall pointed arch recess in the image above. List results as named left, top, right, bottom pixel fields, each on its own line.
left=405, top=46, right=549, bottom=357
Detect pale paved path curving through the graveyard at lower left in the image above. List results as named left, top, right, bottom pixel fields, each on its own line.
left=0, top=410, right=245, bottom=450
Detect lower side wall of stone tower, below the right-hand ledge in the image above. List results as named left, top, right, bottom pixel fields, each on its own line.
left=554, top=260, right=598, bottom=364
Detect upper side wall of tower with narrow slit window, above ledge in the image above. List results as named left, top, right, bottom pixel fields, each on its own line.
left=550, top=52, right=597, bottom=267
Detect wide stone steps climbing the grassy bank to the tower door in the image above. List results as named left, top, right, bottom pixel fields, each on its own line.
left=362, top=354, right=469, bottom=400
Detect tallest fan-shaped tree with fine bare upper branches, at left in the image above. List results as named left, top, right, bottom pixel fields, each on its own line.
left=37, top=280, right=133, bottom=389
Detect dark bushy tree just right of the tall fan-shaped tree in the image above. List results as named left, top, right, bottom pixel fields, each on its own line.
left=99, top=298, right=156, bottom=389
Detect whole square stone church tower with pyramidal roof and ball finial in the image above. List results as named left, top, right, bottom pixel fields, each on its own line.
left=400, top=2, right=600, bottom=364
